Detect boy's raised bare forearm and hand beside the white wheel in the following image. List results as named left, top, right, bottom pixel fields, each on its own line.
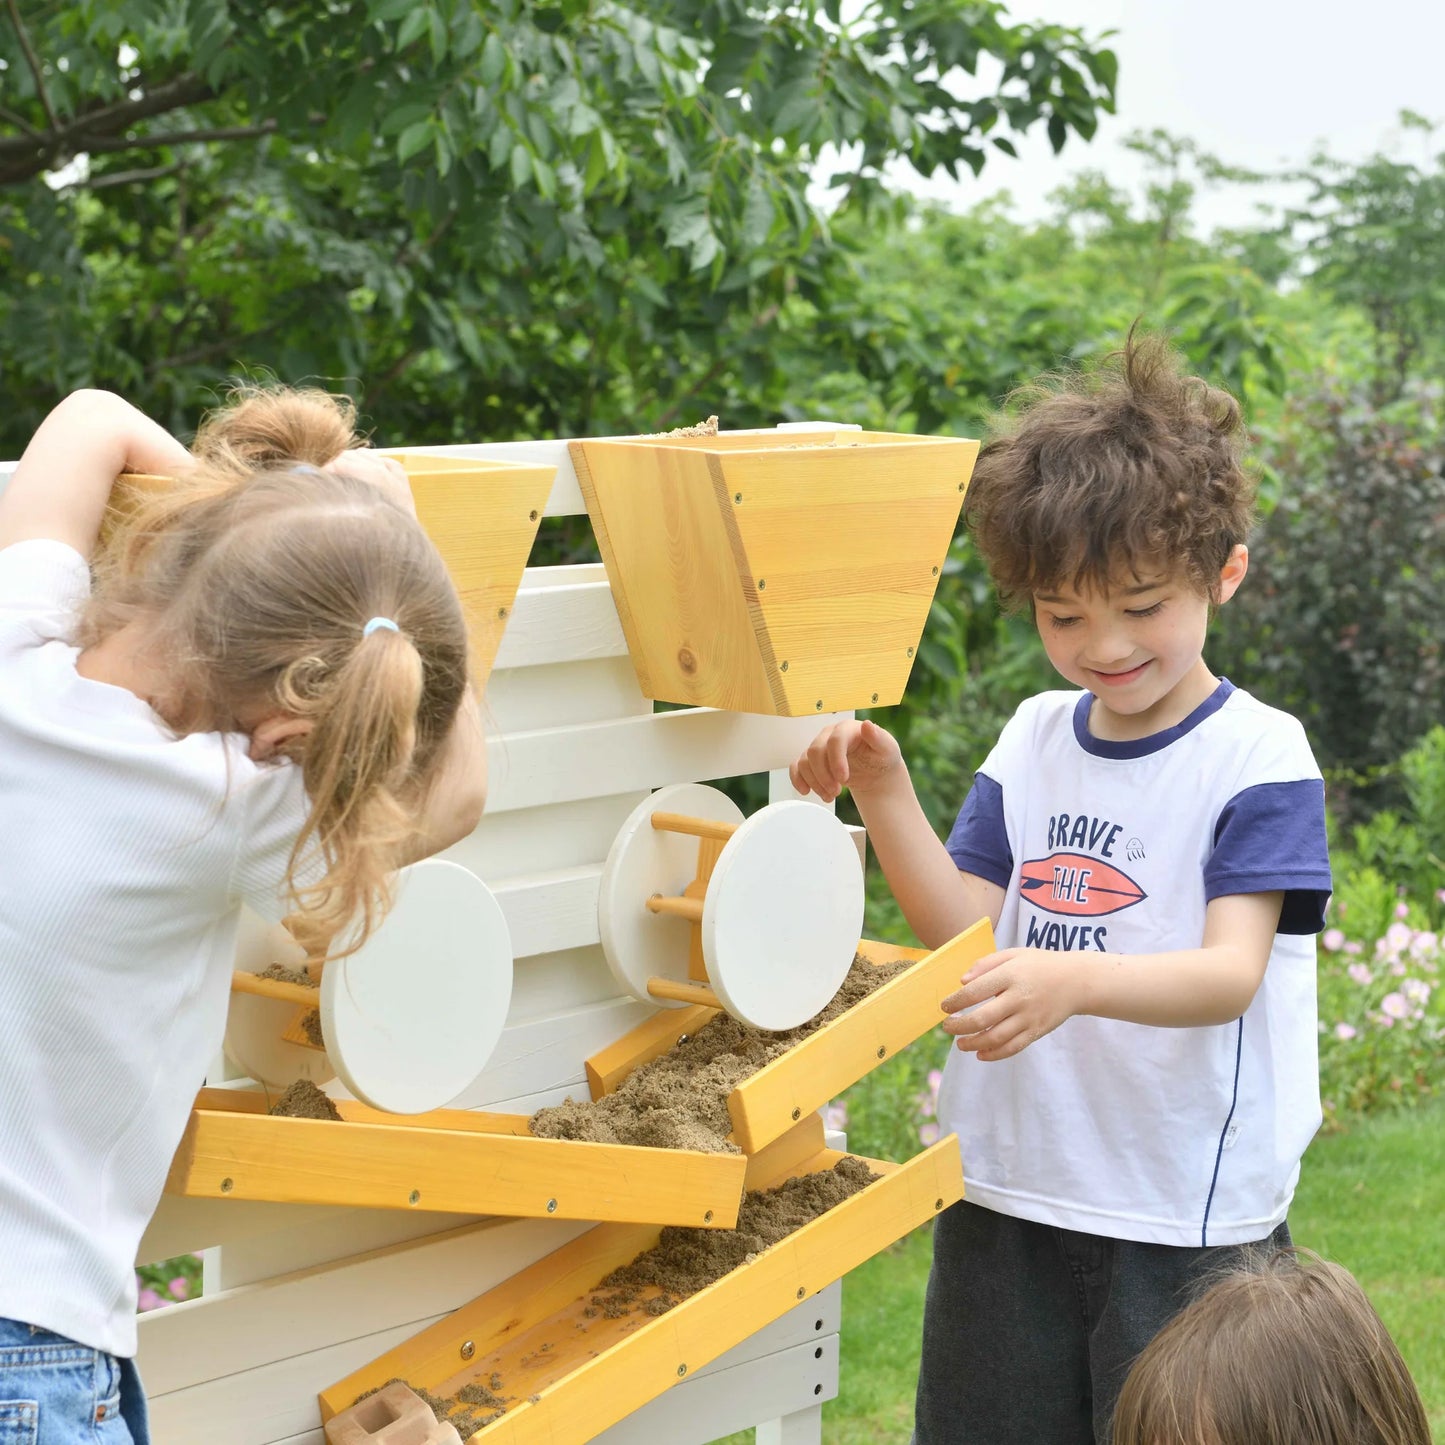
left=789, top=721, right=1004, bottom=948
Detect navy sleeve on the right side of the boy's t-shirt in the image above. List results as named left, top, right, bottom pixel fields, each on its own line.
left=1204, top=777, right=1331, bottom=933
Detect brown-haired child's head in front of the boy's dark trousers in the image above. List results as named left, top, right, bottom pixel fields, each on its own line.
left=1114, top=1250, right=1431, bottom=1445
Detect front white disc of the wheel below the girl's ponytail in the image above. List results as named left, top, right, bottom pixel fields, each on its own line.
left=321, top=858, right=512, bottom=1114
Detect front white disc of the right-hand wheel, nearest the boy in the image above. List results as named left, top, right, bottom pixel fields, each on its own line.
left=702, top=801, right=863, bottom=1030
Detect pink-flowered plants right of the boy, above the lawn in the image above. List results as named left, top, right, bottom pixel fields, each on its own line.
left=1319, top=890, right=1445, bottom=1123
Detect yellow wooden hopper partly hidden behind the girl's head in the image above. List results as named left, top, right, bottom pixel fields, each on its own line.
left=101, top=451, right=556, bottom=692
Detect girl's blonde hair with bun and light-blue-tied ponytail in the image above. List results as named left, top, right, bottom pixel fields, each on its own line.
left=77, top=387, right=467, bottom=957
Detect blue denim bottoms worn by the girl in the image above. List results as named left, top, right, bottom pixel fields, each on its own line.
left=0, top=1319, right=150, bottom=1445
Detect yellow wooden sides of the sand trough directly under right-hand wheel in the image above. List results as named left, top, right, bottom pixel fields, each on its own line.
left=587, top=919, right=994, bottom=1155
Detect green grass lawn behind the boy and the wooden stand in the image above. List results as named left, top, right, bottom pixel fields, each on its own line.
left=718, top=1103, right=1445, bottom=1445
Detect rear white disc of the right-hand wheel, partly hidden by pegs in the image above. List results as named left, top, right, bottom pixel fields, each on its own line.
left=597, top=783, right=743, bottom=1009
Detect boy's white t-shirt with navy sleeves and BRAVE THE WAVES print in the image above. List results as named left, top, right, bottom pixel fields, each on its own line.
left=939, top=682, right=1331, bottom=1246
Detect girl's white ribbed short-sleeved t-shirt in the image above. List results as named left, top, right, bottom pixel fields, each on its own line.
left=0, top=540, right=305, bottom=1355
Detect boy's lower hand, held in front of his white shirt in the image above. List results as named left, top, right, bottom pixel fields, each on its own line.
left=942, top=948, right=1084, bottom=1062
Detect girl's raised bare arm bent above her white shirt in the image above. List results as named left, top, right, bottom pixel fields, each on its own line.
left=0, top=392, right=192, bottom=558
